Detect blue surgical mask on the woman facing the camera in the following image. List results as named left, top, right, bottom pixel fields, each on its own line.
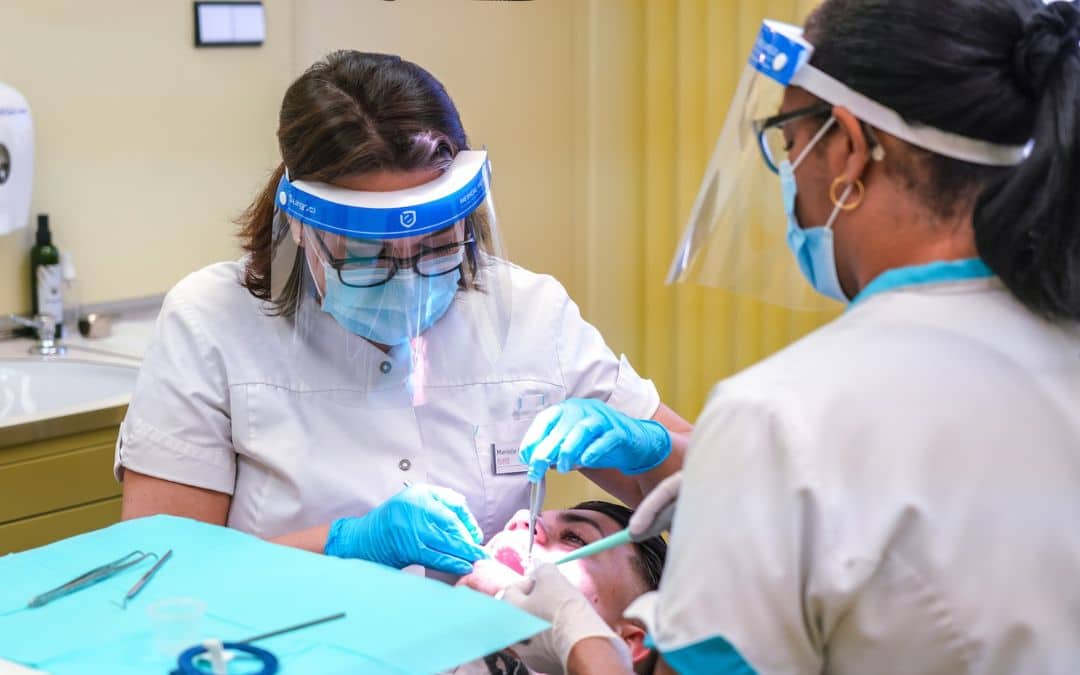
left=323, top=264, right=461, bottom=347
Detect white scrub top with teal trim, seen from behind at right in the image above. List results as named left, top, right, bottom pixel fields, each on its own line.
left=627, top=279, right=1080, bottom=675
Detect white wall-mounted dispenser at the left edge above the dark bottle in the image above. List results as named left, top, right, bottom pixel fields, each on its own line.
left=0, top=82, right=33, bottom=234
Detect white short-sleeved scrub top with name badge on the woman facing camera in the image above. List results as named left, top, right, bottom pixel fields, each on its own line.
left=114, top=262, right=660, bottom=537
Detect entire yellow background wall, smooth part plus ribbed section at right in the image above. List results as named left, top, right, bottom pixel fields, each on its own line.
left=0, top=0, right=827, bottom=503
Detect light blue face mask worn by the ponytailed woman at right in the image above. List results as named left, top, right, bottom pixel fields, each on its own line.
left=777, top=118, right=851, bottom=302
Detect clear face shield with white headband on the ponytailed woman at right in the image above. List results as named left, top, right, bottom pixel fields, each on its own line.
left=667, top=21, right=1030, bottom=310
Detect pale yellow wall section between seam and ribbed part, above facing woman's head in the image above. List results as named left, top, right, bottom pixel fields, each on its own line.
left=294, top=0, right=580, bottom=300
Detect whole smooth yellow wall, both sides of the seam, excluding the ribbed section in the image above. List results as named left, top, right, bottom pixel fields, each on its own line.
left=0, top=0, right=579, bottom=313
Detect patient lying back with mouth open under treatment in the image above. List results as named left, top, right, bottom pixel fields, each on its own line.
left=454, top=501, right=667, bottom=675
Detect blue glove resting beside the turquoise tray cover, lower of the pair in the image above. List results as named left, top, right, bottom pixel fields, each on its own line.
left=324, top=485, right=488, bottom=575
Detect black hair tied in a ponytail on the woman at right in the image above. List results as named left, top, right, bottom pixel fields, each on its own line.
left=807, top=0, right=1080, bottom=320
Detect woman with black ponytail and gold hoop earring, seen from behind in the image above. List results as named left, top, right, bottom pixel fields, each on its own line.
left=505, top=0, right=1080, bottom=675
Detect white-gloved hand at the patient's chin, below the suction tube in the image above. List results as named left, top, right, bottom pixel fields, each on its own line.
left=496, top=563, right=632, bottom=675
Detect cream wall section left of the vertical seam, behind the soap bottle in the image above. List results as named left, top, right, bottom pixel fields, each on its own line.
left=0, top=0, right=292, bottom=313
